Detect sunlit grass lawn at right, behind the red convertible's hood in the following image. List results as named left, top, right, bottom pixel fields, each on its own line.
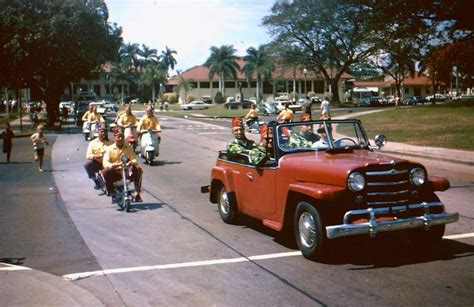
left=357, top=102, right=474, bottom=151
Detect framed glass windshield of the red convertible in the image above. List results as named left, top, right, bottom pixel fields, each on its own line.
left=277, top=120, right=369, bottom=152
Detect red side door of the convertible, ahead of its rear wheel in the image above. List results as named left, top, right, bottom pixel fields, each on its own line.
left=234, top=165, right=276, bottom=218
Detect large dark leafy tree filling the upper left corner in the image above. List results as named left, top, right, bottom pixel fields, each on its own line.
left=0, top=0, right=121, bottom=126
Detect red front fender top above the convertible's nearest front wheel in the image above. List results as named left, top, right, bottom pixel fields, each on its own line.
left=288, top=182, right=346, bottom=202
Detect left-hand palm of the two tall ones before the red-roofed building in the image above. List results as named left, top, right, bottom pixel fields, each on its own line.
left=204, top=45, right=240, bottom=95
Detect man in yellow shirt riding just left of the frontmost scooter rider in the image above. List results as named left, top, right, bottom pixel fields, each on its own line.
left=84, top=127, right=113, bottom=190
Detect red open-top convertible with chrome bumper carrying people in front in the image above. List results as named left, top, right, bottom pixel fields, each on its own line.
left=201, top=119, right=459, bottom=260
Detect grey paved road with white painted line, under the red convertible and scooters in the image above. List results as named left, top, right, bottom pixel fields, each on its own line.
left=0, top=116, right=474, bottom=306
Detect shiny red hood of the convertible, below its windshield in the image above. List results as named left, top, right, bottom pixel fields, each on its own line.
left=280, top=149, right=408, bottom=186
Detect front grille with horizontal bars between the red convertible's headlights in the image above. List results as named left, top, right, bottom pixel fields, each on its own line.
left=365, top=161, right=412, bottom=207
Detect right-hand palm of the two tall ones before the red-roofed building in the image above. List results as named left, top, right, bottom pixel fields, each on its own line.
left=242, top=46, right=275, bottom=101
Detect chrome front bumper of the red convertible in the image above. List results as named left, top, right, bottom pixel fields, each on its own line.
left=326, top=202, right=459, bottom=239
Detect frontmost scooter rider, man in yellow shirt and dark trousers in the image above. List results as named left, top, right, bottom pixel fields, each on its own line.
left=102, top=129, right=143, bottom=202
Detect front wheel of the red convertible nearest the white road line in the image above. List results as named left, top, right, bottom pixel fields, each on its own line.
left=294, top=202, right=329, bottom=260
